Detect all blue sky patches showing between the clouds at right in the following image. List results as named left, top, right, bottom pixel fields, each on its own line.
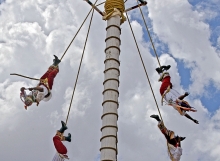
left=132, top=0, right=220, bottom=113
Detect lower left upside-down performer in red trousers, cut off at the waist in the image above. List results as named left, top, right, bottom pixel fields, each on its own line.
left=52, top=121, right=71, bottom=161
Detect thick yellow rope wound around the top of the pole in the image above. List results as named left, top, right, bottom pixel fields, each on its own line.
left=103, top=0, right=126, bottom=24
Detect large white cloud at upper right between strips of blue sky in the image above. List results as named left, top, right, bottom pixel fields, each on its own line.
left=149, top=0, right=219, bottom=95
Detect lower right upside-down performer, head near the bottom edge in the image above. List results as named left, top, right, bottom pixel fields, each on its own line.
left=150, top=115, right=186, bottom=161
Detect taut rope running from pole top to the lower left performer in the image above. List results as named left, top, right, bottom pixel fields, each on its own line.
left=66, top=8, right=95, bottom=124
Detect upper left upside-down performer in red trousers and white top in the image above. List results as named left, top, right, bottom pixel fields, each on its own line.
left=20, top=55, right=60, bottom=110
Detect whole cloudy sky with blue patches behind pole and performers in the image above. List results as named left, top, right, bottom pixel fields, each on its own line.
left=0, top=0, right=220, bottom=161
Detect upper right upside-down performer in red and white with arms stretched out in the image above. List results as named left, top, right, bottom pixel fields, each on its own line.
left=156, top=65, right=199, bottom=124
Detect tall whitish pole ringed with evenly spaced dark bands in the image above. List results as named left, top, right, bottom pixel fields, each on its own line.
left=100, top=3, right=121, bottom=161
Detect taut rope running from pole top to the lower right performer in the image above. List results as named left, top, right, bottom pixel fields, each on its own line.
left=126, top=13, right=172, bottom=161
